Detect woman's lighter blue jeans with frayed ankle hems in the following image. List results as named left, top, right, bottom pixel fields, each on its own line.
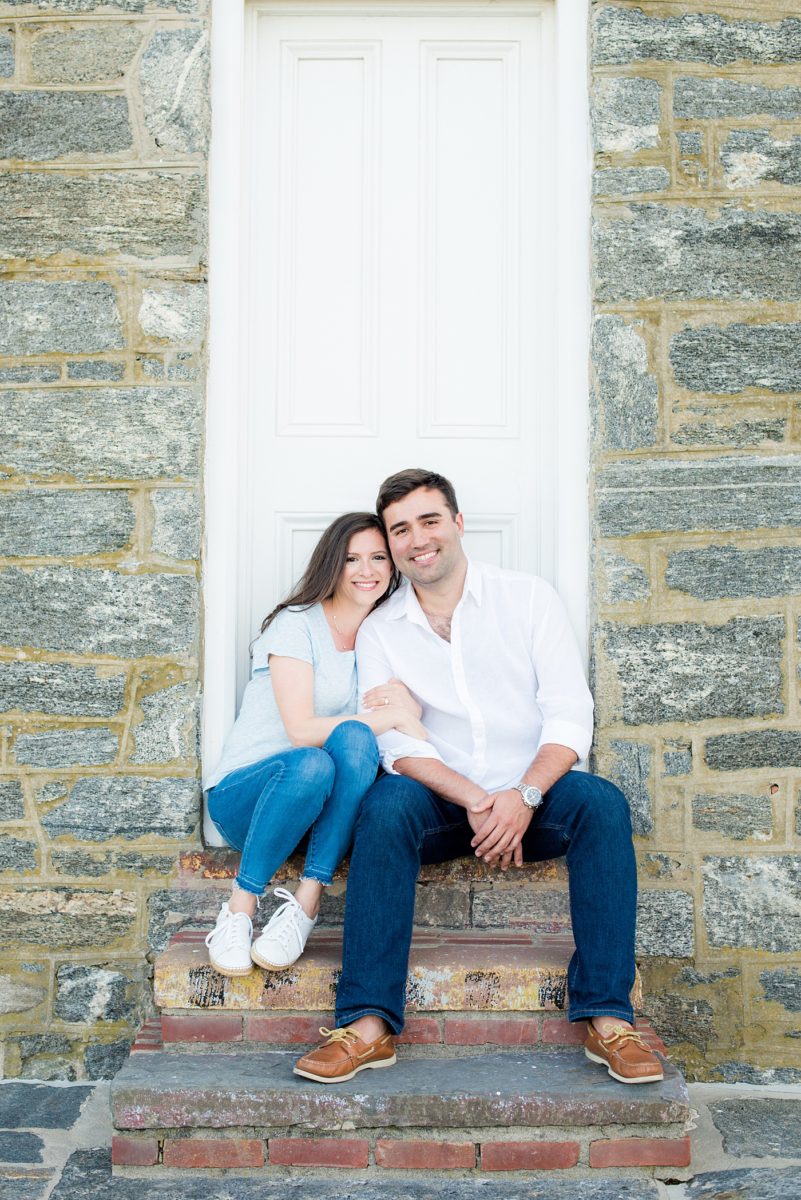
left=209, top=721, right=378, bottom=895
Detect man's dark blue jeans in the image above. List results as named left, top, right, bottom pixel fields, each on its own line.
left=337, top=770, right=637, bottom=1033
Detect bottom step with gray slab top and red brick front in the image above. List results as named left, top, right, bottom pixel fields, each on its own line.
left=112, top=1048, right=689, bottom=1176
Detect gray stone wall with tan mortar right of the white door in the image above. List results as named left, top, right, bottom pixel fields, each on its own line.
left=591, top=0, right=801, bottom=1082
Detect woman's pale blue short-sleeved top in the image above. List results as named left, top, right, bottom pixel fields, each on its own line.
left=204, top=604, right=359, bottom=790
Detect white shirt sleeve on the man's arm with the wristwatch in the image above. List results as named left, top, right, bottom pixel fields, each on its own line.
left=531, top=581, right=594, bottom=762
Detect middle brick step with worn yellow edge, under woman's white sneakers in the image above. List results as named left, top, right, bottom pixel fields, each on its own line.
left=153, top=930, right=642, bottom=1028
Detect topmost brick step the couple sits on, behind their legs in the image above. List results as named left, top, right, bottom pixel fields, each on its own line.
left=165, top=850, right=570, bottom=941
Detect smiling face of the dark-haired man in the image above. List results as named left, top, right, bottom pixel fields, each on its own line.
left=383, top=487, right=464, bottom=588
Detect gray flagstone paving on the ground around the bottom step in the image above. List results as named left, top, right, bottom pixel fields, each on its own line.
left=0, top=1080, right=801, bottom=1200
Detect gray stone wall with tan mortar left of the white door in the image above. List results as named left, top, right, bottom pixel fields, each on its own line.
left=0, top=0, right=209, bottom=1079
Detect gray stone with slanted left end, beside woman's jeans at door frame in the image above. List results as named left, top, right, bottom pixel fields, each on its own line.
left=41, top=775, right=200, bottom=841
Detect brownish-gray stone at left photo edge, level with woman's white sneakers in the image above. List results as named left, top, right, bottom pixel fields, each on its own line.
left=0, top=888, right=139, bottom=952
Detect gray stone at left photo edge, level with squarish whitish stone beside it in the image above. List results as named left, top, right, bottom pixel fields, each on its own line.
left=0, top=282, right=125, bottom=354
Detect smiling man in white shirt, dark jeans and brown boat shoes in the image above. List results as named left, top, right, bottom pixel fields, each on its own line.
left=295, top=470, right=663, bottom=1084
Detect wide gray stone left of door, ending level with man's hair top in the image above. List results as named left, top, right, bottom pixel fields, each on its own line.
left=0, top=386, right=203, bottom=481
